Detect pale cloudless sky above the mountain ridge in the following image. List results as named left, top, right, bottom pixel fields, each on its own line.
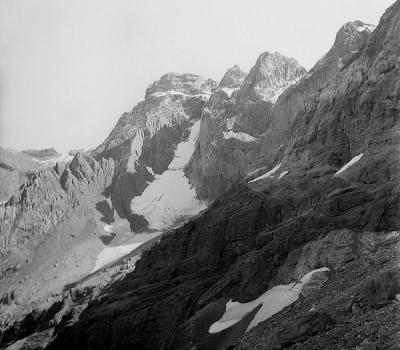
left=0, top=0, right=394, bottom=152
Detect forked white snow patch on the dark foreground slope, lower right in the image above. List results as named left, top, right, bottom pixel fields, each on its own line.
left=209, top=267, right=329, bottom=333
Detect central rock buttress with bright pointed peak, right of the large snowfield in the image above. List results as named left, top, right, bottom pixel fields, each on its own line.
left=187, top=52, right=306, bottom=199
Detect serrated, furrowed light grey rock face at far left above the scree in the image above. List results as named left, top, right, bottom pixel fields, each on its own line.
left=0, top=154, right=114, bottom=276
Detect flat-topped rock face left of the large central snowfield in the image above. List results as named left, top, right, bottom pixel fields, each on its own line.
left=93, top=73, right=215, bottom=231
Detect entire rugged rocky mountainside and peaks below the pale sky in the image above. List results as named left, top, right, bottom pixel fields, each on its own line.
left=0, top=0, right=400, bottom=350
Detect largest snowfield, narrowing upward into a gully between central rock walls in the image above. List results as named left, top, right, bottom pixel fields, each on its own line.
left=131, top=121, right=207, bottom=230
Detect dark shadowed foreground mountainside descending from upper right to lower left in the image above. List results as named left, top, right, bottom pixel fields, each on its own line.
left=30, top=1, right=400, bottom=349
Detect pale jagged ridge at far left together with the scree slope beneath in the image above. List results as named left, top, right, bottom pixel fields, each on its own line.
left=0, top=154, right=114, bottom=334
